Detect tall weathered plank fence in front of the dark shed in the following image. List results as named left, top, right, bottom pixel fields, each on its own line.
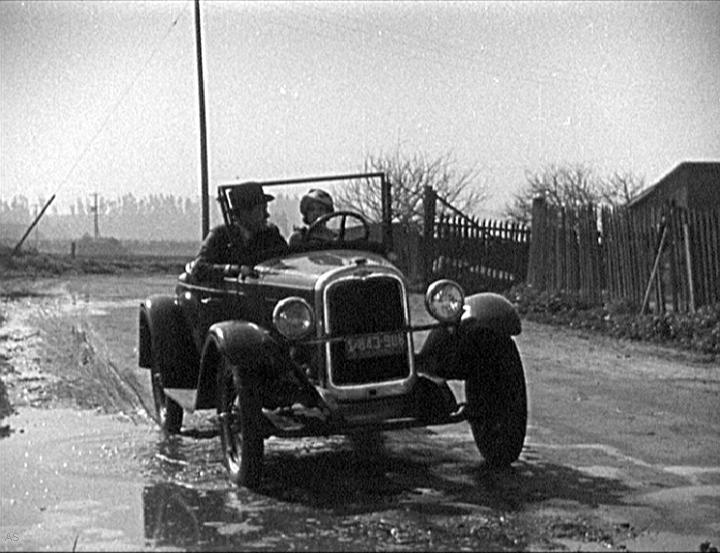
left=527, top=199, right=720, bottom=312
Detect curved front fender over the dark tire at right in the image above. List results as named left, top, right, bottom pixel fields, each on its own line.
left=417, top=292, right=521, bottom=380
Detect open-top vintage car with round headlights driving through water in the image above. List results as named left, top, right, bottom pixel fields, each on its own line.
left=138, top=173, right=527, bottom=488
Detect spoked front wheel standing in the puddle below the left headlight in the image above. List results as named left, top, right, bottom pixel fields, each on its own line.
left=218, top=360, right=264, bottom=489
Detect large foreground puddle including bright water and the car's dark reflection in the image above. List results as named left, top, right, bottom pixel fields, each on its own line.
left=0, top=408, right=528, bottom=551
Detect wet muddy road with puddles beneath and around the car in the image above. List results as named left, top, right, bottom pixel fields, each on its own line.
left=0, top=276, right=720, bottom=551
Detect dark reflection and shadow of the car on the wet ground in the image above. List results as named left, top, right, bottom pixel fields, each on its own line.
left=138, top=433, right=640, bottom=551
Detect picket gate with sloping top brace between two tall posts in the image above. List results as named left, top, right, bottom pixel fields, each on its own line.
left=422, top=187, right=530, bottom=294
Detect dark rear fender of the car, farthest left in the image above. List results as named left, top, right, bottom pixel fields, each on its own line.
left=138, top=295, right=198, bottom=388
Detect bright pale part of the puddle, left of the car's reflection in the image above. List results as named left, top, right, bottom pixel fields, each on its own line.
left=0, top=408, right=156, bottom=550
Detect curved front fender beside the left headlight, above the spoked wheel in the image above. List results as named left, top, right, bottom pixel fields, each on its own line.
left=196, top=320, right=319, bottom=409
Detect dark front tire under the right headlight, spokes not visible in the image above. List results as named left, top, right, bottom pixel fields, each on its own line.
left=465, top=337, right=527, bottom=468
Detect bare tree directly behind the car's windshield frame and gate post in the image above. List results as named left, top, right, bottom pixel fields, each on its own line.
left=336, top=149, right=486, bottom=228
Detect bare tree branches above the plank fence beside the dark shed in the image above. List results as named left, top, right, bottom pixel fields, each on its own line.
left=505, top=164, right=644, bottom=224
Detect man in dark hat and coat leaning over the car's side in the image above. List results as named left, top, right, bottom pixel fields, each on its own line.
left=190, top=182, right=287, bottom=280
